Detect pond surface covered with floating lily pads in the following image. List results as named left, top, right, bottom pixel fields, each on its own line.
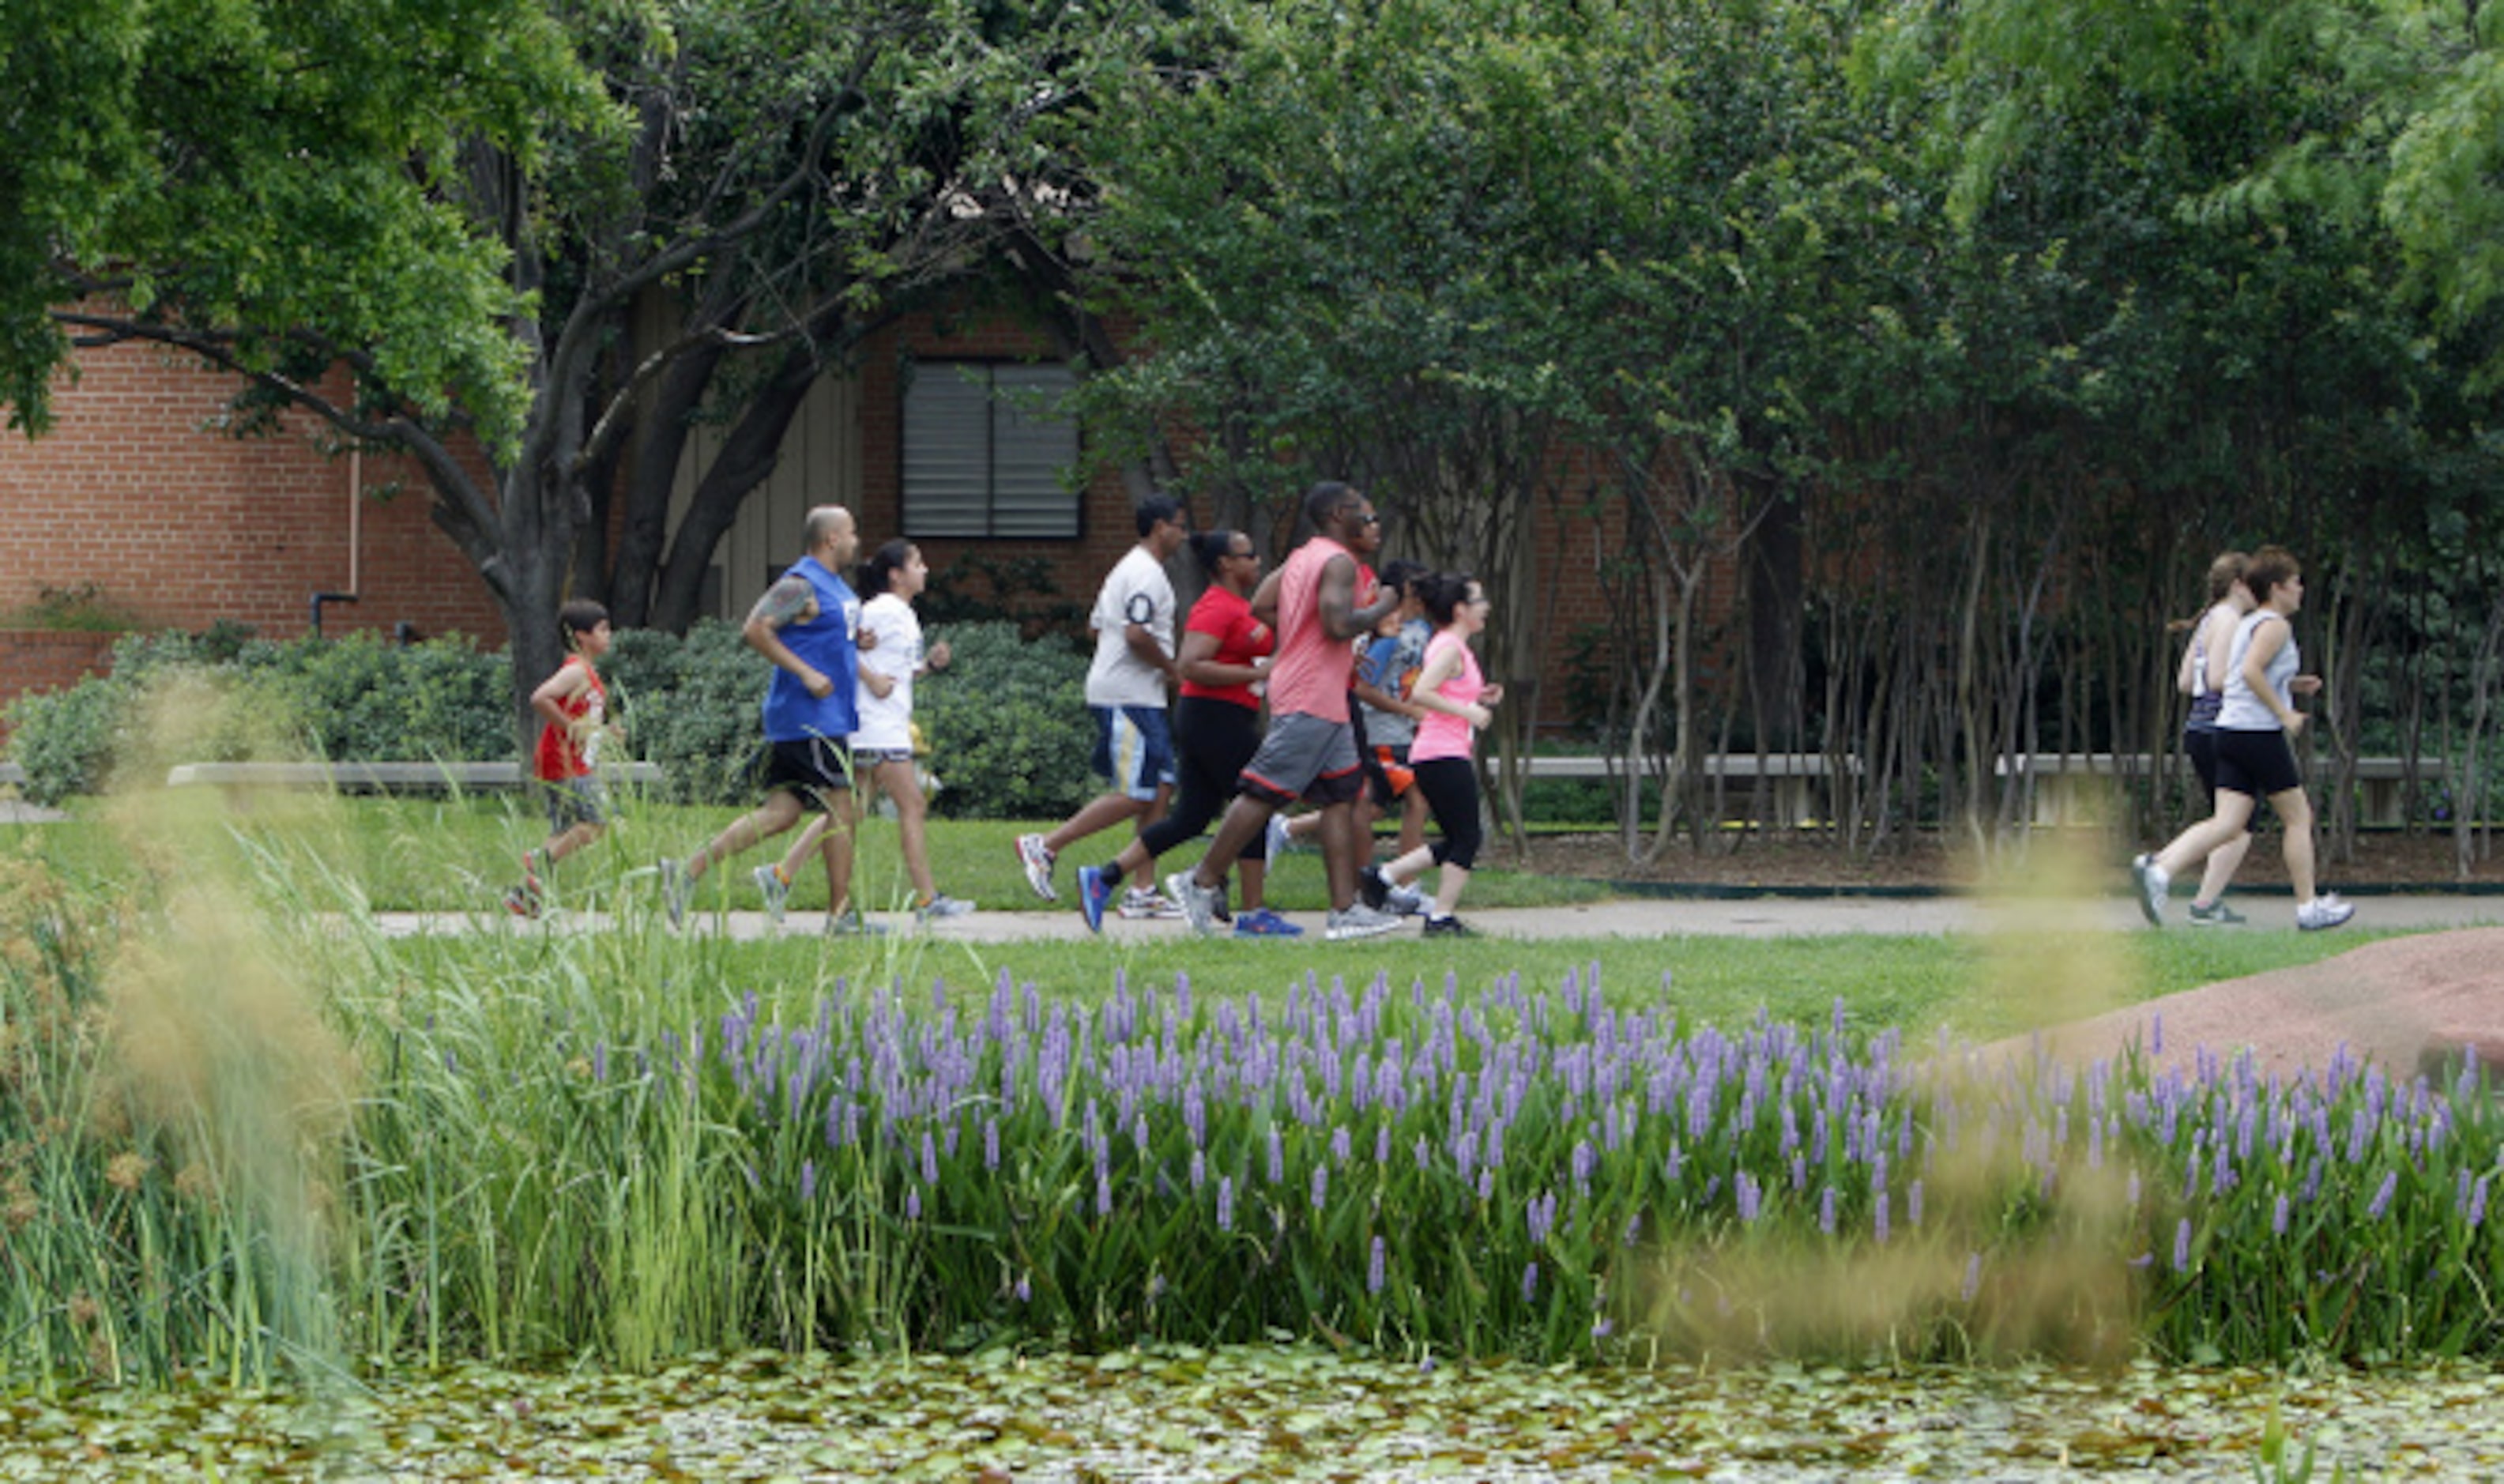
left=0, top=1347, right=2504, bottom=1484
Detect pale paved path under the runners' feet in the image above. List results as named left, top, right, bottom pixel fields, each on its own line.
left=375, top=894, right=2504, bottom=944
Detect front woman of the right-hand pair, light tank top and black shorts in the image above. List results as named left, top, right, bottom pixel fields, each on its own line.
left=2131, top=545, right=2356, bottom=931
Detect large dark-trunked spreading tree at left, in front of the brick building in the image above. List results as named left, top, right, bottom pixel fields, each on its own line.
left=12, top=0, right=1162, bottom=733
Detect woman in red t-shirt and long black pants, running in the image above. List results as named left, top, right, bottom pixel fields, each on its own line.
left=1079, top=530, right=1302, bottom=939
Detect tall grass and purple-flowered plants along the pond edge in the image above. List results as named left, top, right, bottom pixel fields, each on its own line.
left=0, top=820, right=2504, bottom=1381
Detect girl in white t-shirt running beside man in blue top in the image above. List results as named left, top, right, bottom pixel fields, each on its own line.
left=756, top=540, right=974, bottom=921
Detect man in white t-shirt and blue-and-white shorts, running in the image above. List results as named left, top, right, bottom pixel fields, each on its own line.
left=1017, top=495, right=1189, bottom=916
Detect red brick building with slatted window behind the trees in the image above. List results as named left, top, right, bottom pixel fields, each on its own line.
left=0, top=318, right=1662, bottom=730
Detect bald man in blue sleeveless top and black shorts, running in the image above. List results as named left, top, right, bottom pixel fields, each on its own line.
left=661, top=506, right=861, bottom=931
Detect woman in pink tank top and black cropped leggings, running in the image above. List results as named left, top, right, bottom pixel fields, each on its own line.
left=1362, top=573, right=1505, bottom=936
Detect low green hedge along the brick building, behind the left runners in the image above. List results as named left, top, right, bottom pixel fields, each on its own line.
left=8, top=620, right=1094, bottom=819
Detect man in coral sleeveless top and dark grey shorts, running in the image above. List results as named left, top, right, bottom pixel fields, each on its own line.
left=1165, top=480, right=1399, bottom=941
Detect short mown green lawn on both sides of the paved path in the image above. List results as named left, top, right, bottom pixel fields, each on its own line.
left=0, top=796, right=2423, bottom=1038
